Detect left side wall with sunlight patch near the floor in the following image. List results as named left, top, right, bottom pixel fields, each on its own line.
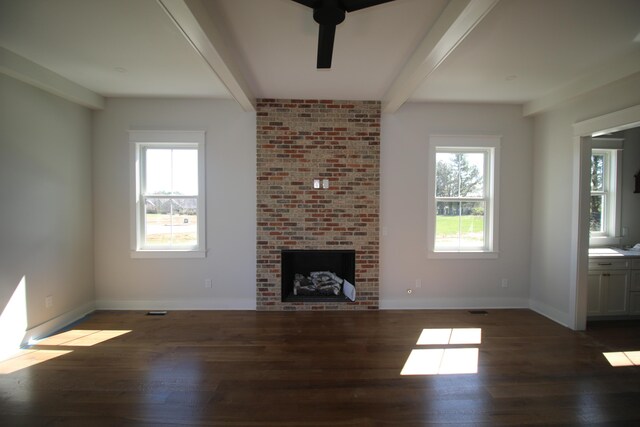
left=0, top=75, right=94, bottom=352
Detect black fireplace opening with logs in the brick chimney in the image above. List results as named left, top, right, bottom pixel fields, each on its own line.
left=280, top=250, right=356, bottom=302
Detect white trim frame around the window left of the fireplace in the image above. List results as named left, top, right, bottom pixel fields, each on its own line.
left=129, top=130, right=206, bottom=258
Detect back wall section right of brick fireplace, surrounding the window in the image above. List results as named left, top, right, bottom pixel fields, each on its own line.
left=380, top=104, right=532, bottom=308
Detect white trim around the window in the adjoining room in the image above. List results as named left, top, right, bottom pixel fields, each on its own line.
left=589, top=138, right=623, bottom=247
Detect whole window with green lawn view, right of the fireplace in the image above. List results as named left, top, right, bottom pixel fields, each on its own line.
left=428, top=136, right=500, bottom=258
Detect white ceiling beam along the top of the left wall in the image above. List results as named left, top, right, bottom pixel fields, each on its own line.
left=0, top=47, right=104, bottom=110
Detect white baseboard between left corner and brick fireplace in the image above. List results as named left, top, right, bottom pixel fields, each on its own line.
left=96, top=298, right=256, bottom=310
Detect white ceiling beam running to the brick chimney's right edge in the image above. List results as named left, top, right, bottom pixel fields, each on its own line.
left=382, top=0, right=499, bottom=113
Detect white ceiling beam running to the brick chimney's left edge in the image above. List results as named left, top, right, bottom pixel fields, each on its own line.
left=157, top=0, right=255, bottom=111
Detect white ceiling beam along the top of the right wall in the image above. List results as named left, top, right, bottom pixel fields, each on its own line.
left=522, top=50, right=640, bottom=117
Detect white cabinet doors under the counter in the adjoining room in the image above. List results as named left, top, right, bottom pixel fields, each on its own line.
left=587, top=270, right=628, bottom=316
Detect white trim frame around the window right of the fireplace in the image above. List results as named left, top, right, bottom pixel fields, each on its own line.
left=427, top=135, right=502, bottom=259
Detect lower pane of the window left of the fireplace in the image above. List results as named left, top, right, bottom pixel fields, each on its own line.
left=144, top=197, right=198, bottom=247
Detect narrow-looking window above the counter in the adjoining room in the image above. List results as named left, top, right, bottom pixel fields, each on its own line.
left=589, top=144, right=622, bottom=246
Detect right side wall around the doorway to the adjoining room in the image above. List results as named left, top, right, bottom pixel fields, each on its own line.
left=531, top=75, right=640, bottom=325
